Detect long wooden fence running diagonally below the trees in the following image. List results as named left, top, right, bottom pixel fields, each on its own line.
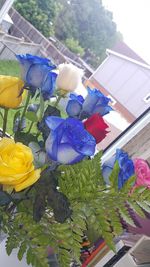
left=9, top=8, right=93, bottom=77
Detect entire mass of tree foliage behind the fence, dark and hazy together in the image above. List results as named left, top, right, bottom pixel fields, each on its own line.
left=15, top=0, right=121, bottom=67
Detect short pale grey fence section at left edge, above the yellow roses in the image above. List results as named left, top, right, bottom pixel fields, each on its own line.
left=0, top=31, right=41, bottom=60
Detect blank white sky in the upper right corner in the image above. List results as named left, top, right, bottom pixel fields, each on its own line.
left=103, top=0, right=150, bottom=64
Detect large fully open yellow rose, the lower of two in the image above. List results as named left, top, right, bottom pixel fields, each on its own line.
left=0, top=137, right=41, bottom=192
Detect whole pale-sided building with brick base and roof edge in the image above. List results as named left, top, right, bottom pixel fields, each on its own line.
left=89, top=42, right=150, bottom=123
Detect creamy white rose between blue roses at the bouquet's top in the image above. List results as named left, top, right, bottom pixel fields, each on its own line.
left=56, top=63, right=84, bottom=92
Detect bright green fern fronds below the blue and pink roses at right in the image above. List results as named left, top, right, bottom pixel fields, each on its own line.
left=59, top=155, right=150, bottom=252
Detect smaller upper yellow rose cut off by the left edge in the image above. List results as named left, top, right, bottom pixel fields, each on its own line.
left=0, top=75, right=24, bottom=108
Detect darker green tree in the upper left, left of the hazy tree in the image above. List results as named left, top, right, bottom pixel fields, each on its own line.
left=15, top=0, right=59, bottom=37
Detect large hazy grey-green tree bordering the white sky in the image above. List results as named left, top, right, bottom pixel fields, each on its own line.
left=55, top=0, right=118, bottom=66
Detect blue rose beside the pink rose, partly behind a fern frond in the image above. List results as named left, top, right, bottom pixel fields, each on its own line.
left=102, top=149, right=134, bottom=189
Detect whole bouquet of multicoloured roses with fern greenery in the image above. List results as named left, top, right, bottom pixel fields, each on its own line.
left=0, top=54, right=150, bottom=267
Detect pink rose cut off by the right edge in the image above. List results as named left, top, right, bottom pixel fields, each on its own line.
left=133, top=158, right=150, bottom=188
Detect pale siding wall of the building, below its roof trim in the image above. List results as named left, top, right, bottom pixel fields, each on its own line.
left=92, top=54, right=150, bottom=117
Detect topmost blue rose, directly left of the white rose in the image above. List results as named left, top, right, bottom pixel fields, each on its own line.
left=16, top=54, right=57, bottom=100
